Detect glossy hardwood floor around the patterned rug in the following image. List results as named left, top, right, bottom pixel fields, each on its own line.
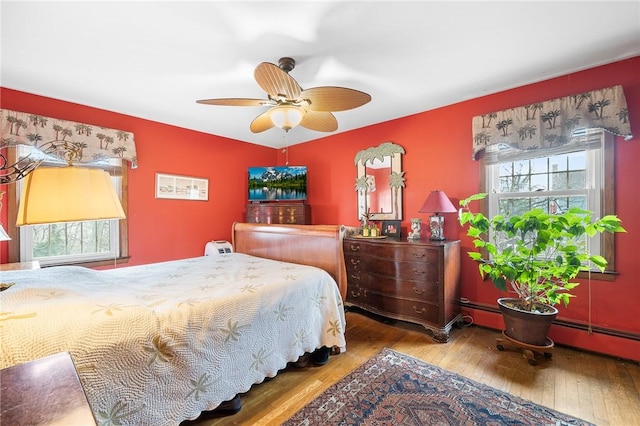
left=183, top=311, right=640, bottom=426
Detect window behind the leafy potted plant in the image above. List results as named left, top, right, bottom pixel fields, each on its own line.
left=481, top=130, right=614, bottom=276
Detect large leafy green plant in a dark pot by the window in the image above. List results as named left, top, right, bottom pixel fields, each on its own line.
left=458, top=193, right=626, bottom=347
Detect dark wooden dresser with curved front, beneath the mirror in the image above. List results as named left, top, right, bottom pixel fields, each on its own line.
left=343, top=238, right=462, bottom=343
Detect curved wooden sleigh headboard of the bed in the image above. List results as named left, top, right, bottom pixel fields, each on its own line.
left=231, top=222, right=347, bottom=300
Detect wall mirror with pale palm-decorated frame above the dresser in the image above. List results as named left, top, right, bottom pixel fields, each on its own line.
left=355, top=142, right=404, bottom=220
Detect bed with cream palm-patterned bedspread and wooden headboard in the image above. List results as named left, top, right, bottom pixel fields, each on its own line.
left=0, top=223, right=346, bottom=425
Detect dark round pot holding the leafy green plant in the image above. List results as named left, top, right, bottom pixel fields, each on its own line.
left=498, top=297, right=558, bottom=346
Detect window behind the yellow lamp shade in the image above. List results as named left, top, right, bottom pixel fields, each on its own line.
left=16, top=146, right=127, bottom=265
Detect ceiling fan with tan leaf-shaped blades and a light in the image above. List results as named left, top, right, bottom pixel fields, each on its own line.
left=196, top=58, right=371, bottom=133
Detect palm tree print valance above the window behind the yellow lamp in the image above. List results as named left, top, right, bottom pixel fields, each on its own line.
left=0, top=109, right=137, bottom=168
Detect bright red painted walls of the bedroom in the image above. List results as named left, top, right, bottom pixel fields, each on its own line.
left=1, top=57, right=640, bottom=360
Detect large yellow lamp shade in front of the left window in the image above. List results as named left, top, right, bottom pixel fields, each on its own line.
left=16, top=166, right=125, bottom=226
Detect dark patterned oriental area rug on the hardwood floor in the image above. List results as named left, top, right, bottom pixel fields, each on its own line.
left=284, top=348, right=590, bottom=426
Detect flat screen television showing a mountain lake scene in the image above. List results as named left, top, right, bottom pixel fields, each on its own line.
left=248, top=166, right=307, bottom=202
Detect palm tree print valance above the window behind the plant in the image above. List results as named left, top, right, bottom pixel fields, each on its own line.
left=473, top=86, right=633, bottom=159
